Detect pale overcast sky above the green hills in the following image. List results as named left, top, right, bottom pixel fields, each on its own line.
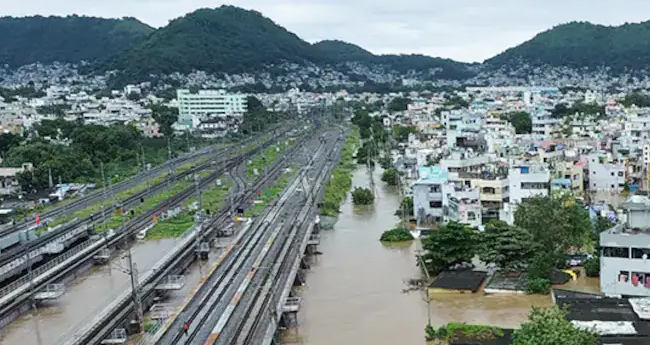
left=5, top=0, right=650, bottom=61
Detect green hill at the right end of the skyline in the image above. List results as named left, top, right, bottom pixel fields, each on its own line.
left=485, top=22, right=650, bottom=71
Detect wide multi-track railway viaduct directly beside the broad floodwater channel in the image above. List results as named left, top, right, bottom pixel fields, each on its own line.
left=148, top=132, right=339, bottom=344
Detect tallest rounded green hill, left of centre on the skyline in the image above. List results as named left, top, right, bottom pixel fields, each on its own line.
left=110, top=6, right=318, bottom=76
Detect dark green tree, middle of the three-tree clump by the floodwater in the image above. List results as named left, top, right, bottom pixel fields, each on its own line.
left=477, top=221, right=535, bottom=271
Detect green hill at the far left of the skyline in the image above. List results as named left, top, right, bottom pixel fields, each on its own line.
left=0, top=16, right=154, bottom=67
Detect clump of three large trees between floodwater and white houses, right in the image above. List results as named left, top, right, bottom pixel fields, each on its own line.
left=422, top=197, right=592, bottom=293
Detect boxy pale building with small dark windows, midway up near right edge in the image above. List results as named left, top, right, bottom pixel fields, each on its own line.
left=587, top=153, right=626, bottom=191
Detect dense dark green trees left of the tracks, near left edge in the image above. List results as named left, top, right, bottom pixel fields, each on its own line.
left=0, top=119, right=202, bottom=190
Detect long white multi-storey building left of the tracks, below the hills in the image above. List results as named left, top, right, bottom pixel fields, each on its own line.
left=176, top=89, right=247, bottom=127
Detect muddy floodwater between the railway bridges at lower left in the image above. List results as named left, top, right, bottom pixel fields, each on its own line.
left=0, top=239, right=177, bottom=345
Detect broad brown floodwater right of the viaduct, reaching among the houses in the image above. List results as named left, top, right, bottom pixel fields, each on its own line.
left=283, top=169, right=598, bottom=345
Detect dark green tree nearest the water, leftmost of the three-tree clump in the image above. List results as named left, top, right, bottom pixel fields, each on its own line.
left=422, top=222, right=477, bottom=274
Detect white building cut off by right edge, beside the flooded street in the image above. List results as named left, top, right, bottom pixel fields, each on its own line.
left=600, top=195, right=650, bottom=297
